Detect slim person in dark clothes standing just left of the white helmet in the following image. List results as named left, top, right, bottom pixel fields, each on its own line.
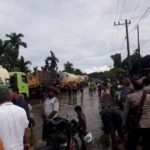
left=74, top=106, right=87, bottom=150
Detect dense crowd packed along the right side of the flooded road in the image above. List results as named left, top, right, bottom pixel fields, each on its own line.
left=98, top=77, right=150, bottom=150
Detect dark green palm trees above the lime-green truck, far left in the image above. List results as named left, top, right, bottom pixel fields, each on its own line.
left=0, top=33, right=31, bottom=73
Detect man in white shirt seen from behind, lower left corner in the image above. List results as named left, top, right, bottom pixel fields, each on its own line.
left=0, top=89, right=30, bottom=150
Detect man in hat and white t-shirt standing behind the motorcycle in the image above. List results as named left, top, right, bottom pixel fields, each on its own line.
left=42, top=87, right=59, bottom=144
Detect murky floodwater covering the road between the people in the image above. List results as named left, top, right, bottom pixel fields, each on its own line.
left=32, top=89, right=103, bottom=150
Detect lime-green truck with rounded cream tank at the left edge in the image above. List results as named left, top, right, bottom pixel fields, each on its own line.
left=0, top=65, right=29, bottom=97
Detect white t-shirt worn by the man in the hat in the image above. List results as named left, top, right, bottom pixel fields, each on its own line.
left=44, top=97, right=59, bottom=118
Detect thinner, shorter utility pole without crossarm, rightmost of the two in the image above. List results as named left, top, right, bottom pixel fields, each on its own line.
left=137, top=25, right=141, bottom=74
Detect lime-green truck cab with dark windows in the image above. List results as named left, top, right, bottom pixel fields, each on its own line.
left=9, top=72, right=29, bottom=97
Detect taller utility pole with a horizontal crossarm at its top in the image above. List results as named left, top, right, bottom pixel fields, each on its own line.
left=114, top=19, right=132, bottom=72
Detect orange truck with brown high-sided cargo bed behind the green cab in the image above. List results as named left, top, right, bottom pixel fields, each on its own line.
left=28, top=70, right=59, bottom=98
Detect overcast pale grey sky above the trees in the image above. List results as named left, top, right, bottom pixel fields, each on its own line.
left=0, top=0, right=150, bottom=73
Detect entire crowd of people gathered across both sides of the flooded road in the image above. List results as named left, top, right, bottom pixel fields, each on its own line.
left=0, top=76, right=150, bottom=150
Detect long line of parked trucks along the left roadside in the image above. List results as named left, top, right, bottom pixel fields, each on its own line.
left=0, top=66, right=88, bottom=97
